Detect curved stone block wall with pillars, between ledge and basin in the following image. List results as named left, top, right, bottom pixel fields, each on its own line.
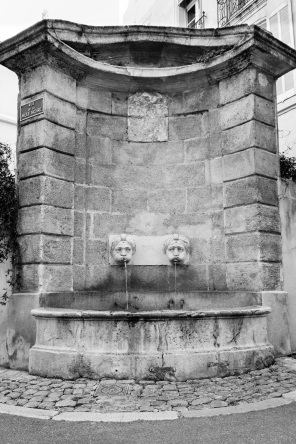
left=18, top=62, right=281, bottom=292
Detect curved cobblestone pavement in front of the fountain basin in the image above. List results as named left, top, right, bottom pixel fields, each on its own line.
left=0, top=358, right=296, bottom=413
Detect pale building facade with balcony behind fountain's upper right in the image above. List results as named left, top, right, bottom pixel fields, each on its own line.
left=123, top=0, right=296, bottom=156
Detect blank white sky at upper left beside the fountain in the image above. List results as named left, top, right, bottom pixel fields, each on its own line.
left=0, top=0, right=128, bottom=118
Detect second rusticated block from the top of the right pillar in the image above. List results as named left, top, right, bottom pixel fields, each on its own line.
left=221, top=94, right=275, bottom=129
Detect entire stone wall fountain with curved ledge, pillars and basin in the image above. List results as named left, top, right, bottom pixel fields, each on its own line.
left=0, top=20, right=296, bottom=380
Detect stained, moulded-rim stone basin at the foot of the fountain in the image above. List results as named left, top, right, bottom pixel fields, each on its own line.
left=30, top=306, right=273, bottom=381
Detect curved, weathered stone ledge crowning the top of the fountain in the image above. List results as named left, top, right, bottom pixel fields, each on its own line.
left=0, top=20, right=296, bottom=87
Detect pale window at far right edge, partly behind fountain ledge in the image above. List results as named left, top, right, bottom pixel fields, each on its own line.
left=269, top=5, right=294, bottom=96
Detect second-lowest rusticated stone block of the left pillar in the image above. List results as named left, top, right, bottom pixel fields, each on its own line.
left=19, top=234, right=72, bottom=264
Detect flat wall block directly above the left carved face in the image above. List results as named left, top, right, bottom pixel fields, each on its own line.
left=93, top=214, right=128, bottom=238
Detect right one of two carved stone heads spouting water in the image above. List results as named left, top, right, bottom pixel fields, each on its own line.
left=163, top=233, right=190, bottom=265
